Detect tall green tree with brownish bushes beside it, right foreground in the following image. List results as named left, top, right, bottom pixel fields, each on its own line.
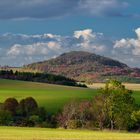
left=58, top=80, right=140, bottom=131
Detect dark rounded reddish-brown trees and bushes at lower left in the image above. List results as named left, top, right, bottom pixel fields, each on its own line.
left=0, top=97, right=56, bottom=127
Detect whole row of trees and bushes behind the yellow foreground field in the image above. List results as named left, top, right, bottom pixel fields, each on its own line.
left=0, top=80, right=140, bottom=131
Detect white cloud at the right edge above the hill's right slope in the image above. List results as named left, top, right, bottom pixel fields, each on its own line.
left=113, top=28, right=140, bottom=67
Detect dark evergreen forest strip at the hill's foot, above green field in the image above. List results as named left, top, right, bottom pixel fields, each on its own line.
left=0, top=70, right=86, bottom=87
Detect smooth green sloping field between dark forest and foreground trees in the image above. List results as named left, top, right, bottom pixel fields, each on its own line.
left=0, top=79, right=97, bottom=112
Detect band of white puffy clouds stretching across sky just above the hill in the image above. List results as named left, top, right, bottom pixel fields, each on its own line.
left=0, top=28, right=140, bottom=67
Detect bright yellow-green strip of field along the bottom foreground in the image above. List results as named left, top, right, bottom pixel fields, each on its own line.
left=0, top=127, right=140, bottom=140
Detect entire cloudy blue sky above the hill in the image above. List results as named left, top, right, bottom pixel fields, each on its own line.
left=0, top=0, right=140, bottom=68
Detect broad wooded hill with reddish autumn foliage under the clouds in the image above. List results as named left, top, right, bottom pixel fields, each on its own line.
left=24, top=51, right=140, bottom=83
